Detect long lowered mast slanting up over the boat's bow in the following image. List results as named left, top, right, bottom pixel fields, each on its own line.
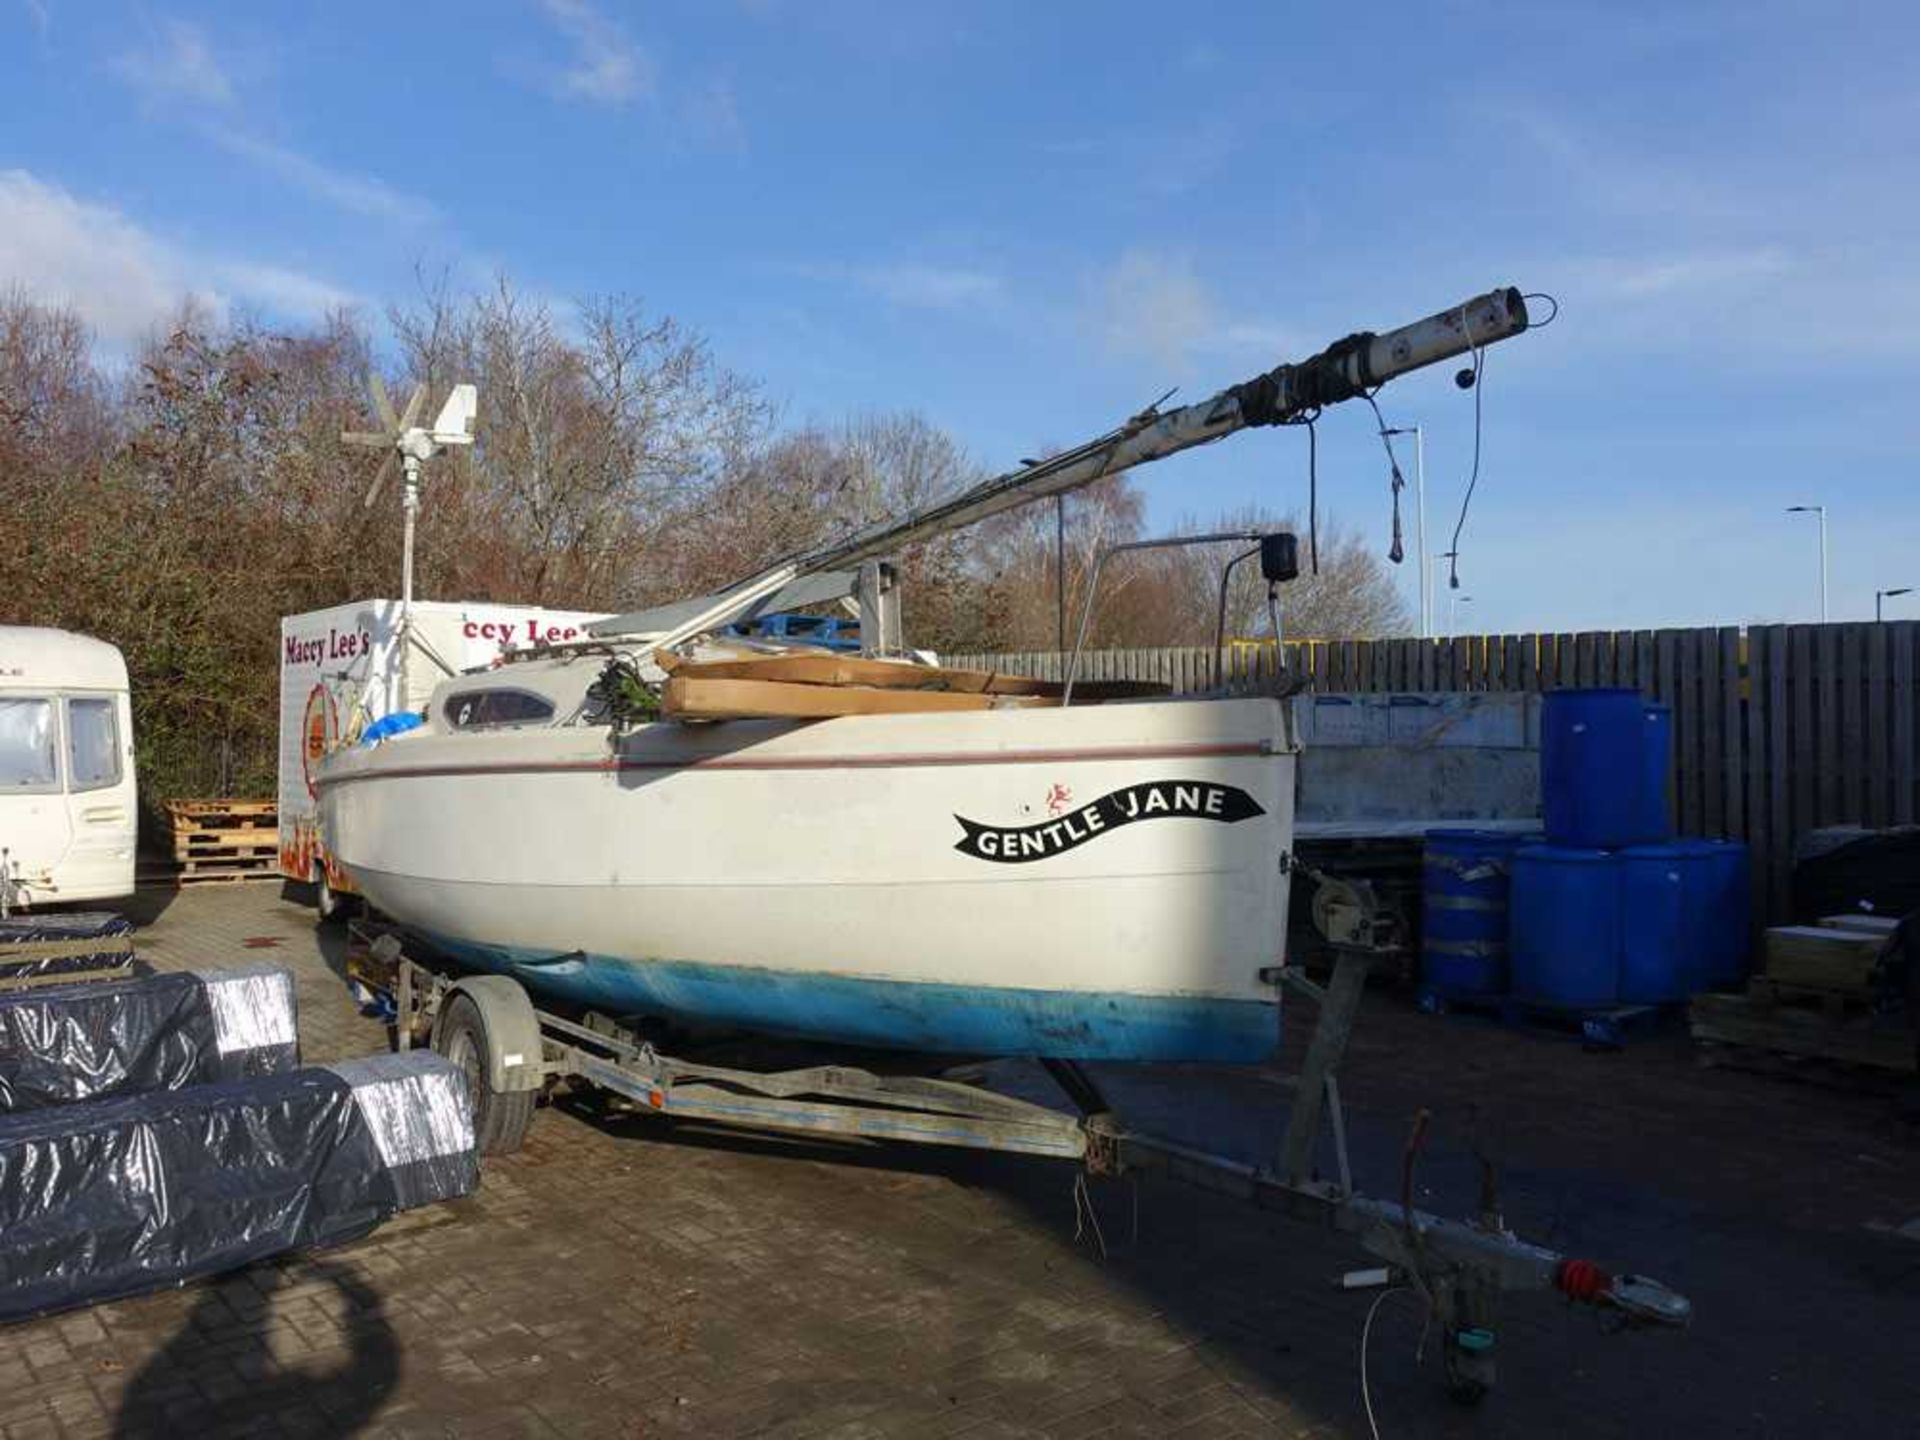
left=591, top=288, right=1526, bottom=647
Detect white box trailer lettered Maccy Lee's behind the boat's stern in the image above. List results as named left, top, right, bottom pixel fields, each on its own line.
left=278, top=599, right=605, bottom=908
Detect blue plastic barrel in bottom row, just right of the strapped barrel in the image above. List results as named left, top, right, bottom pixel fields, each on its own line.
left=1507, top=845, right=1620, bottom=1010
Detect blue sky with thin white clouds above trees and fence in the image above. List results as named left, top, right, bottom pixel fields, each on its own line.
left=0, top=0, right=1920, bottom=632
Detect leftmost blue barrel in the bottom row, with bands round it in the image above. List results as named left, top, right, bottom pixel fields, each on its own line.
left=1421, top=829, right=1521, bottom=998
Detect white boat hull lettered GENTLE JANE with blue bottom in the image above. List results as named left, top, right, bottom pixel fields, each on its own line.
left=321, top=699, right=1294, bottom=1060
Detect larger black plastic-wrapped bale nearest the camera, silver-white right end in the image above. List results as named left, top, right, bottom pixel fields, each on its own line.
left=0, top=1050, right=480, bottom=1321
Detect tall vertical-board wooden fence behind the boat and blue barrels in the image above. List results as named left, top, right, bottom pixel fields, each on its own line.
left=945, top=620, right=1920, bottom=920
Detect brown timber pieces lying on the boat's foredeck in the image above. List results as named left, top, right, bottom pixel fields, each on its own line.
left=653, top=651, right=1169, bottom=720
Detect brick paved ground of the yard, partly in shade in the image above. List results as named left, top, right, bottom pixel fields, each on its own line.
left=0, top=887, right=1920, bottom=1440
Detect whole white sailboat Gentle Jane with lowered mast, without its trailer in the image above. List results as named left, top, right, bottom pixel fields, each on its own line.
left=319, top=290, right=1526, bottom=1062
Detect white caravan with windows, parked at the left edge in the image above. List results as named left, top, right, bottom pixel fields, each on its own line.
left=0, top=626, right=138, bottom=910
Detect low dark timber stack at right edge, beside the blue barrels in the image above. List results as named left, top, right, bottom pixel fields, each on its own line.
left=1690, top=916, right=1916, bottom=1071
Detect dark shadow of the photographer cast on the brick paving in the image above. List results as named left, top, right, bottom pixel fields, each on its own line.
left=113, top=1258, right=401, bottom=1440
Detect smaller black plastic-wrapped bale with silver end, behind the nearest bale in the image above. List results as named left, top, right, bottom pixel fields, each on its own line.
left=0, top=964, right=300, bottom=1114
